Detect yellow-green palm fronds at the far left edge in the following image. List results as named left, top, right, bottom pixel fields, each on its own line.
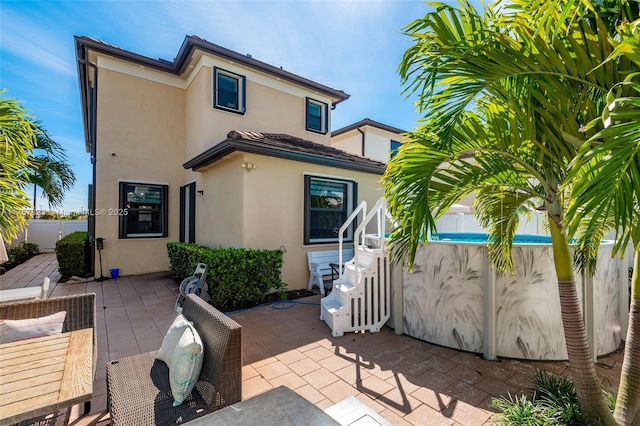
left=0, top=90, right=35, bottom=243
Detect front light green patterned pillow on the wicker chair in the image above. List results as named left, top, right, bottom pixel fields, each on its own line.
left=169, top=325, right=203, bottom=407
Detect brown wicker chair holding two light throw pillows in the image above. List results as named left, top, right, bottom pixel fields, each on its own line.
left=107, top=294, right=242, bottom=426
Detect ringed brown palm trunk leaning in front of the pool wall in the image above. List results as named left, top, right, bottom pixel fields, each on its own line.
left=549, top=218, right=616, bottom=425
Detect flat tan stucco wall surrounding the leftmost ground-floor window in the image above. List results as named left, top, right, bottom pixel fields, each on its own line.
left=95, top=69, right=185, bottom=275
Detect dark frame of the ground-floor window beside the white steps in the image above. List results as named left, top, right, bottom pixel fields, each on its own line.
left=303, top=174, right=358, bottom=245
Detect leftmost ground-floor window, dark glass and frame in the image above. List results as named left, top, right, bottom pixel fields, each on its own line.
left=118, top=182, right=169, bottom=238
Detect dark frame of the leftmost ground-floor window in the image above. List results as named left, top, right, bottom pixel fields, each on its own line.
left=118, top=181, right=169, bottom=239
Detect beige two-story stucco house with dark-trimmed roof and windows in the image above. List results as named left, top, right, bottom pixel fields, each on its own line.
left=75, top=36, right=385, bottom=289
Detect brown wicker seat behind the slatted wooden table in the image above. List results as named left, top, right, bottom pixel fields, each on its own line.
left=0, top=293, right=98, bottom=424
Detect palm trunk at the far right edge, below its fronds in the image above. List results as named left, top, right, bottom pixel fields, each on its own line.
left=614, top=250, right=640, bottom=425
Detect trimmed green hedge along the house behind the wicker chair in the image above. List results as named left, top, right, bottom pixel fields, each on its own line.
left=167, top=242, right=287, bottom=308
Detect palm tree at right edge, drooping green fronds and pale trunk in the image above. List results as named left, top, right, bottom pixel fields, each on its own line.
left=567, top=18, right=640, bottom=425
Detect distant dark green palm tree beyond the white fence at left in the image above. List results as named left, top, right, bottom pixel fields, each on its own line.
left=26, top=121, right=76, bottom=218
